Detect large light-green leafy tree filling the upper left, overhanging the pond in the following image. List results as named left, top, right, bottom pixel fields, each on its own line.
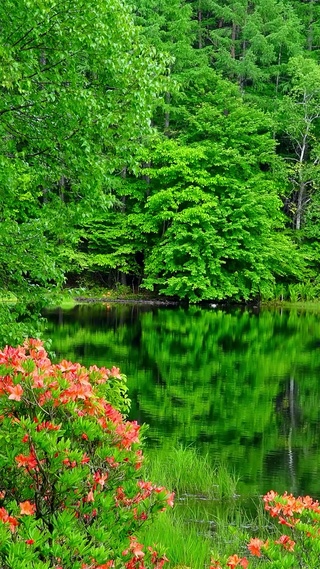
left=0, top=0, right=164, bottom=298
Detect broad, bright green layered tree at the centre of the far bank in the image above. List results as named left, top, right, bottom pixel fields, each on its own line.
left=140, top=71, right=299, bottom=301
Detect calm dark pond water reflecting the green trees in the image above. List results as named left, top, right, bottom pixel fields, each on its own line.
left=46, top=305, right=320, bottom=497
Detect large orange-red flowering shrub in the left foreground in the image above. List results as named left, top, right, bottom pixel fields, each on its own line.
left=0, top=339, right=173, bottom=569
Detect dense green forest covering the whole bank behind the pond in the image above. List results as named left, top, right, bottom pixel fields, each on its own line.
left=0, top=0, right=320, bottom=302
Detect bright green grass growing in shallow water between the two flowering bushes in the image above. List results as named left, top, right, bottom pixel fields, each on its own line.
left=139, top=447, right=270, bottom=569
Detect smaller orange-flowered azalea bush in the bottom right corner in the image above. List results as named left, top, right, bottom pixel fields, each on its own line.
left=210, top=491, right=320, bottom=569
